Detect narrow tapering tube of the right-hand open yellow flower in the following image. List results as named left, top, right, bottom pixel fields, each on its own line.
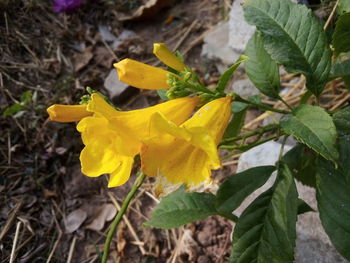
left=182, top=97, right=232, bottom=144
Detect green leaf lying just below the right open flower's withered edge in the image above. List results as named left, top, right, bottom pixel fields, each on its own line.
left=144, top=187, right=217, bottom=229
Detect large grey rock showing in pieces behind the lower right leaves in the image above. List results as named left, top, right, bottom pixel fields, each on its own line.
left=235, top=141, right=348, bottom=263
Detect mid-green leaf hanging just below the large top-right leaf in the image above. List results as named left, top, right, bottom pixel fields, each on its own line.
left=245, top=31, right=280, bottom=99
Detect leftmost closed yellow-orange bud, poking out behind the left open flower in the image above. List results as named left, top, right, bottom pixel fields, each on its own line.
left=47, top=104, right=92, bottom=122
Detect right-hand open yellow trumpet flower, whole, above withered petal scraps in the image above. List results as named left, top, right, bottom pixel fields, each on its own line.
left=141, top=97, right=231, bottom=187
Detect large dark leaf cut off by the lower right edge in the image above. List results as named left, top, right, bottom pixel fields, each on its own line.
left=316, top=135, right=350, bottom=260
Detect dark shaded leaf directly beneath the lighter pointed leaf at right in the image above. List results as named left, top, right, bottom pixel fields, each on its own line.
left=282, top=144, right=316, bottom=187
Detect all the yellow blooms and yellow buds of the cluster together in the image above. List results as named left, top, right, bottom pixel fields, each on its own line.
left=47, top=43, right=231, bottom=193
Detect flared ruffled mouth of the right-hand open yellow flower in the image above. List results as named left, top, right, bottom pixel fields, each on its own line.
left=141, top=113, right=221, bottom=186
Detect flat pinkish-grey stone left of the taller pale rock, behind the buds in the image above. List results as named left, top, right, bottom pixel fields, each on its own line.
left=201, top=22, right=240, bottom=73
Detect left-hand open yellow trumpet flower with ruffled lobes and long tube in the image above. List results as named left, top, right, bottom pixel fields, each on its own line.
left=62, top=93, right=199, bottom=187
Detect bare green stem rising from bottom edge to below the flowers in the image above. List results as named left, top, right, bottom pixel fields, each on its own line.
left=102, top=172, right=146, bottom=263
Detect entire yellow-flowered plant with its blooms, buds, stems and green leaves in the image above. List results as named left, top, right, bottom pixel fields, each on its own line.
left=47, top=5, right=350, bottom=263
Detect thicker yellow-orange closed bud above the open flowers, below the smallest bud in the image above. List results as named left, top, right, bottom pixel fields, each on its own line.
left=114, top=58, right=170, bottom=90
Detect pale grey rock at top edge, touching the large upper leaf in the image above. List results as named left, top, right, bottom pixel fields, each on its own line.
left=228, top=0, right=255, bottom=54
